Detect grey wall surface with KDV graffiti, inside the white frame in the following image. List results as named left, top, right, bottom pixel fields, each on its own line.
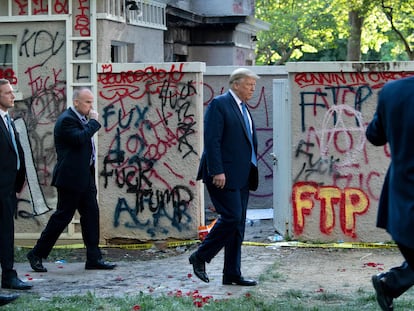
left=0, top=21, right=66, bottom=238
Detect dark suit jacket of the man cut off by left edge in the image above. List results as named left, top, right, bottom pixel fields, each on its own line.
left=0, top=116, right=26, bottom=195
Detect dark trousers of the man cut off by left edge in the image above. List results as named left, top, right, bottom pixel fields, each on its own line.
left=0, top=190, right=17, bottom=279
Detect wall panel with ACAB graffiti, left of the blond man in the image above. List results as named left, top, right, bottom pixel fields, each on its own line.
left=98, top=63, right=205, bottom=240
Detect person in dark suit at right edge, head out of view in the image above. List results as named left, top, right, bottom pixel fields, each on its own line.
left=366, top=77, right=414, bottom=311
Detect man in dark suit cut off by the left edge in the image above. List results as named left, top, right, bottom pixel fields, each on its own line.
left=0, top=79, right=32, bottom=305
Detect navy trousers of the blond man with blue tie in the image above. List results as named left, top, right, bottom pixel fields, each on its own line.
left=197, top=183, right=249, bottom=277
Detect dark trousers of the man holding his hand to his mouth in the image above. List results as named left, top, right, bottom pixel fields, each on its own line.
left=33, top=185, right=102, bottom=261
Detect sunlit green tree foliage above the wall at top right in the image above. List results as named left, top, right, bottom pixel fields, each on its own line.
left=256, top=0, right=414, bottom=65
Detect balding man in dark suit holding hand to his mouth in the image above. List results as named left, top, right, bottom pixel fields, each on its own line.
left=27, top=88, right=115, bottom=272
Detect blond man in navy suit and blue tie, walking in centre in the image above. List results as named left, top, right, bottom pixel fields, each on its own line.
left=189, top=68, right=259, bottom=286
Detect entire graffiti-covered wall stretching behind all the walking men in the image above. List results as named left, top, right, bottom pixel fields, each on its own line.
left=9, top=30, right=414, bottom=247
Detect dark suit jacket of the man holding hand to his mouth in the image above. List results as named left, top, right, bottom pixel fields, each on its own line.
left=52, top=108, right=101, bottom=192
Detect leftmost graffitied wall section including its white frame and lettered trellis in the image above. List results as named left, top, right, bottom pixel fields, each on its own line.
left=4, top=0, right=96, bottom=239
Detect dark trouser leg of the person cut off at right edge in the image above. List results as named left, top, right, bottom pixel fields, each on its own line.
left=385, top=243, right=414, bottom=298
